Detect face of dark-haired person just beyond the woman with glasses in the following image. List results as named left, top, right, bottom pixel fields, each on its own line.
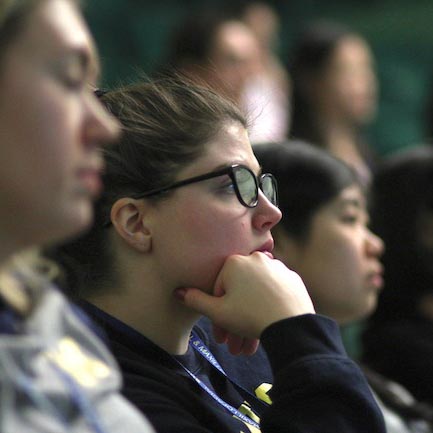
left=278, top=185, right=383, bottom=323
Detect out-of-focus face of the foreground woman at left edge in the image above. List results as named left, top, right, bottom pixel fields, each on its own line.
left=0, top=0, right=117, bottom=245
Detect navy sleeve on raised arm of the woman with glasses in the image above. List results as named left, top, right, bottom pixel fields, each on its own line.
left=261, top=314, right=386, bottom=433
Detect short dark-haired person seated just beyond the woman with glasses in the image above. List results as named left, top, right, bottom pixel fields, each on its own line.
left=255, top=143, right=433, bottom=433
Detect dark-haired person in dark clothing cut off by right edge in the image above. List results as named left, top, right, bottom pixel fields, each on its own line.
left=363, top=146, right=433, bottom=403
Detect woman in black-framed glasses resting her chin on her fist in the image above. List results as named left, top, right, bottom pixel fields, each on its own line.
left=48, top=78, right=384, bottom=433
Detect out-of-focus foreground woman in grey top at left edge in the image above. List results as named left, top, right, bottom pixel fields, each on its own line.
left=0, top=0, right=153, bottom=433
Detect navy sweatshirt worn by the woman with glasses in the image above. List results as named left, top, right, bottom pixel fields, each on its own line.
left=79, top=300, right=385, bottom=433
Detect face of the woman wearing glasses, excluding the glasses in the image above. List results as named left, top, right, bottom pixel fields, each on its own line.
left=145, top=122, right=281, bottom=292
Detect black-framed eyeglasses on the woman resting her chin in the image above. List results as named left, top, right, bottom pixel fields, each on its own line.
left=134, top=164, right=278, bottom=208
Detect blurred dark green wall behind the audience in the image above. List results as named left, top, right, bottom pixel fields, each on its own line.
left=86, top=0, right=433, bottom=155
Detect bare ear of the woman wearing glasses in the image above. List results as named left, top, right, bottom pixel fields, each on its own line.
left=110, top=197, right=152, bottom=253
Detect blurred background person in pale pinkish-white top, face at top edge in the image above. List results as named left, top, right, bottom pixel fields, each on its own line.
left=240, top=1, right=290, bottom=144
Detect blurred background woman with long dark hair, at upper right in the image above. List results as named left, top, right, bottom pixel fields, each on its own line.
left=289, top=21, right=378, bottom=183
